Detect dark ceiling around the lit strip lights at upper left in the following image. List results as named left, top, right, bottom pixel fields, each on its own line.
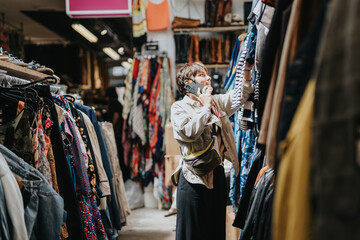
left=0, top=0, right=132, bottom=60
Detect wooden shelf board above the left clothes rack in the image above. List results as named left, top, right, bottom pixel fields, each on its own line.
left=0, top=60, right=49, bottom=80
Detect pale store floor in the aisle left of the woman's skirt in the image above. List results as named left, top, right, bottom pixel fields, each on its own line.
left=118, top=208, right=176, bottom=240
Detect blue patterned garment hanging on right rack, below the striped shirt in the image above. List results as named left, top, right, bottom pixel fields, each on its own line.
left=240, top=129, right=257, bottom=197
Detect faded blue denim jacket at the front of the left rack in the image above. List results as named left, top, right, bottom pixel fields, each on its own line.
left=0, top=144, right=66, bottom=239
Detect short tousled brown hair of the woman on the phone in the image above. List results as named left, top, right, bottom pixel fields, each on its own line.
left=176, top=62, right=208, bottom=94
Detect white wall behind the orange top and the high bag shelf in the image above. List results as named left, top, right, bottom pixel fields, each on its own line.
left=144, top=0, right=244, bottom=92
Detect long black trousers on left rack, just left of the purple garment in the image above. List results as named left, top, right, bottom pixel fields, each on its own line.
left=35, top=85, right=85, bottom=240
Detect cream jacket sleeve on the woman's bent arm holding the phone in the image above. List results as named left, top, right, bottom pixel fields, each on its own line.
left=171, top=102, right=211, bottom=142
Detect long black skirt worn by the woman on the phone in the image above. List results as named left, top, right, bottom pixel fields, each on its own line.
left=176, top=166, right=227, bottom=240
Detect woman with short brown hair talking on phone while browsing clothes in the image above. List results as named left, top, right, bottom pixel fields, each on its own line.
left=171, top=62, right=254, bottom=240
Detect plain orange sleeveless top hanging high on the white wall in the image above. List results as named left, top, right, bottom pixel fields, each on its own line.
left=146, top=0, right=170, bottom=31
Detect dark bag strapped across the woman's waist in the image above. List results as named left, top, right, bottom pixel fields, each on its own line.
left=184, top=136, right=221, bottom=177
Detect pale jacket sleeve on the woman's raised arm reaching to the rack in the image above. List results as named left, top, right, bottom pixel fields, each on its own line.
left=213, top=81, right=255, bottom=117
